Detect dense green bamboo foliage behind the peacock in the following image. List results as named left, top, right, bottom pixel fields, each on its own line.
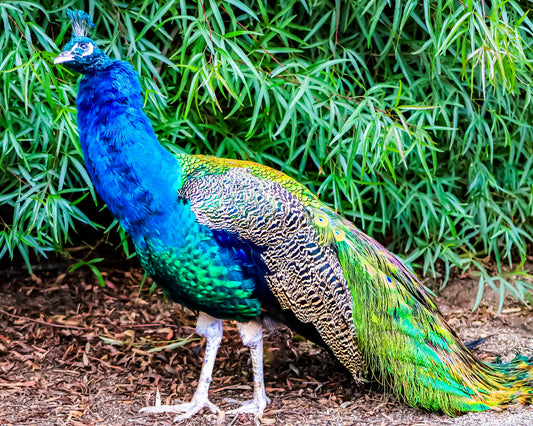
left=0, top=0, right=533, bottom=303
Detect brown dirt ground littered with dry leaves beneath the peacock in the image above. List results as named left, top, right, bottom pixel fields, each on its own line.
left=0, top=255, right=533, bottom=426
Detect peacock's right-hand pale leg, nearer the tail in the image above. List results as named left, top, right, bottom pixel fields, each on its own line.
left=226, top=321, right=270, bottom=419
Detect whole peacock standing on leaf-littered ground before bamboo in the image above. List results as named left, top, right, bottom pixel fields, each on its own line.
left=54, top=11, right=533, bottom=421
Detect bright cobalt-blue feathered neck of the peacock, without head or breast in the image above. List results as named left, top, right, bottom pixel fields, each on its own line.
left=77, top=61, right=181, bottom=240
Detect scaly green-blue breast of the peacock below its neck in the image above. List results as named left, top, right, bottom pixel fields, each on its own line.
left=135, top=200, right=261, bottom=321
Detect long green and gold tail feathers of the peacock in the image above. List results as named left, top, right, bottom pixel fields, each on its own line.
left=337, top=224, right=533, bottom=415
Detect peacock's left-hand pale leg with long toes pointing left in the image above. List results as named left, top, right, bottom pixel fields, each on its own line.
left=141, top=313, right=222, bottom=422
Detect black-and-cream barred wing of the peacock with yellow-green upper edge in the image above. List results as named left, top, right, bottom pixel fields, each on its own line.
left=178, top=157, right=363, bottom=376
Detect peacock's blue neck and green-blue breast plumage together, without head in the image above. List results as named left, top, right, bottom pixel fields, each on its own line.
left=77, top=61, right=260, bottom=320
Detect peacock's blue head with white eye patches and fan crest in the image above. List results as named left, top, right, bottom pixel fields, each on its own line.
left=54, top=10, right=114, bottom=74
